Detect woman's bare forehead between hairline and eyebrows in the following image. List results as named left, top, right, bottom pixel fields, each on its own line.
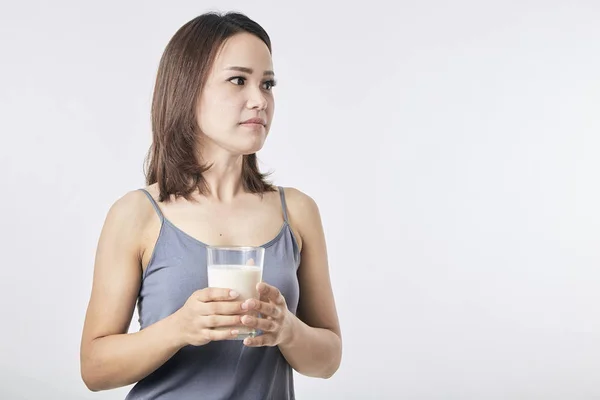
left=213, top=33, right=273, bottom=75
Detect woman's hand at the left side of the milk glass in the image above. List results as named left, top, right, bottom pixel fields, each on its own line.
left=173, top=288, right=246, bottom=346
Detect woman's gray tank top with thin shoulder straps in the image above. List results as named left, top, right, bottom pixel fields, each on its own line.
left=126, top=187, right=300, bottom=400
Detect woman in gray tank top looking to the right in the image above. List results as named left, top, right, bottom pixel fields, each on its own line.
left=81, top=13, right=342, bottom=400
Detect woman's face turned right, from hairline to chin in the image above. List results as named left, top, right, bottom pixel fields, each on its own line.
left=196, top=33, right=275, bottom=155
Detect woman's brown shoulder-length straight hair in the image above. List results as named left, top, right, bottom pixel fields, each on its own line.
left=145, top=12, right=276, bottom=201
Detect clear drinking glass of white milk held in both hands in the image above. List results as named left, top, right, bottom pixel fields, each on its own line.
left=207, top=246, right=265, bottom=340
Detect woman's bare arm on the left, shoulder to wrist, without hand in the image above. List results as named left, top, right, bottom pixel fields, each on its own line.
left=80, top=192, right=183, bottom=391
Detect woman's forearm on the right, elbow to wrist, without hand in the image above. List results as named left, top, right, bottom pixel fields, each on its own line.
left=279, top=316, right=342, bottom=378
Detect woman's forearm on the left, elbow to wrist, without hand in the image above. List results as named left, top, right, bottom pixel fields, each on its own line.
left=81, top=315, right=184, bottom=391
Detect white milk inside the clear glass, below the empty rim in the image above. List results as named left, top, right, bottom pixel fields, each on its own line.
left=208, top=264, right=262, bottom=339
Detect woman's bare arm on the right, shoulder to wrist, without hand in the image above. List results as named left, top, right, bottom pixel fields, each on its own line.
left=279, top=189, right=342, bottom=378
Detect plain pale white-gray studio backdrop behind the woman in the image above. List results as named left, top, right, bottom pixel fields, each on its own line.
left=0, top=0, right=600, bottom=400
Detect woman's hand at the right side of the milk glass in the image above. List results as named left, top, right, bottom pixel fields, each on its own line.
left=242, top=282, right=295, bottom=347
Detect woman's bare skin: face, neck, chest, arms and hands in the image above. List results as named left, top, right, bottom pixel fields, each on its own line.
left=80, top=33, right=342, bottom=391
